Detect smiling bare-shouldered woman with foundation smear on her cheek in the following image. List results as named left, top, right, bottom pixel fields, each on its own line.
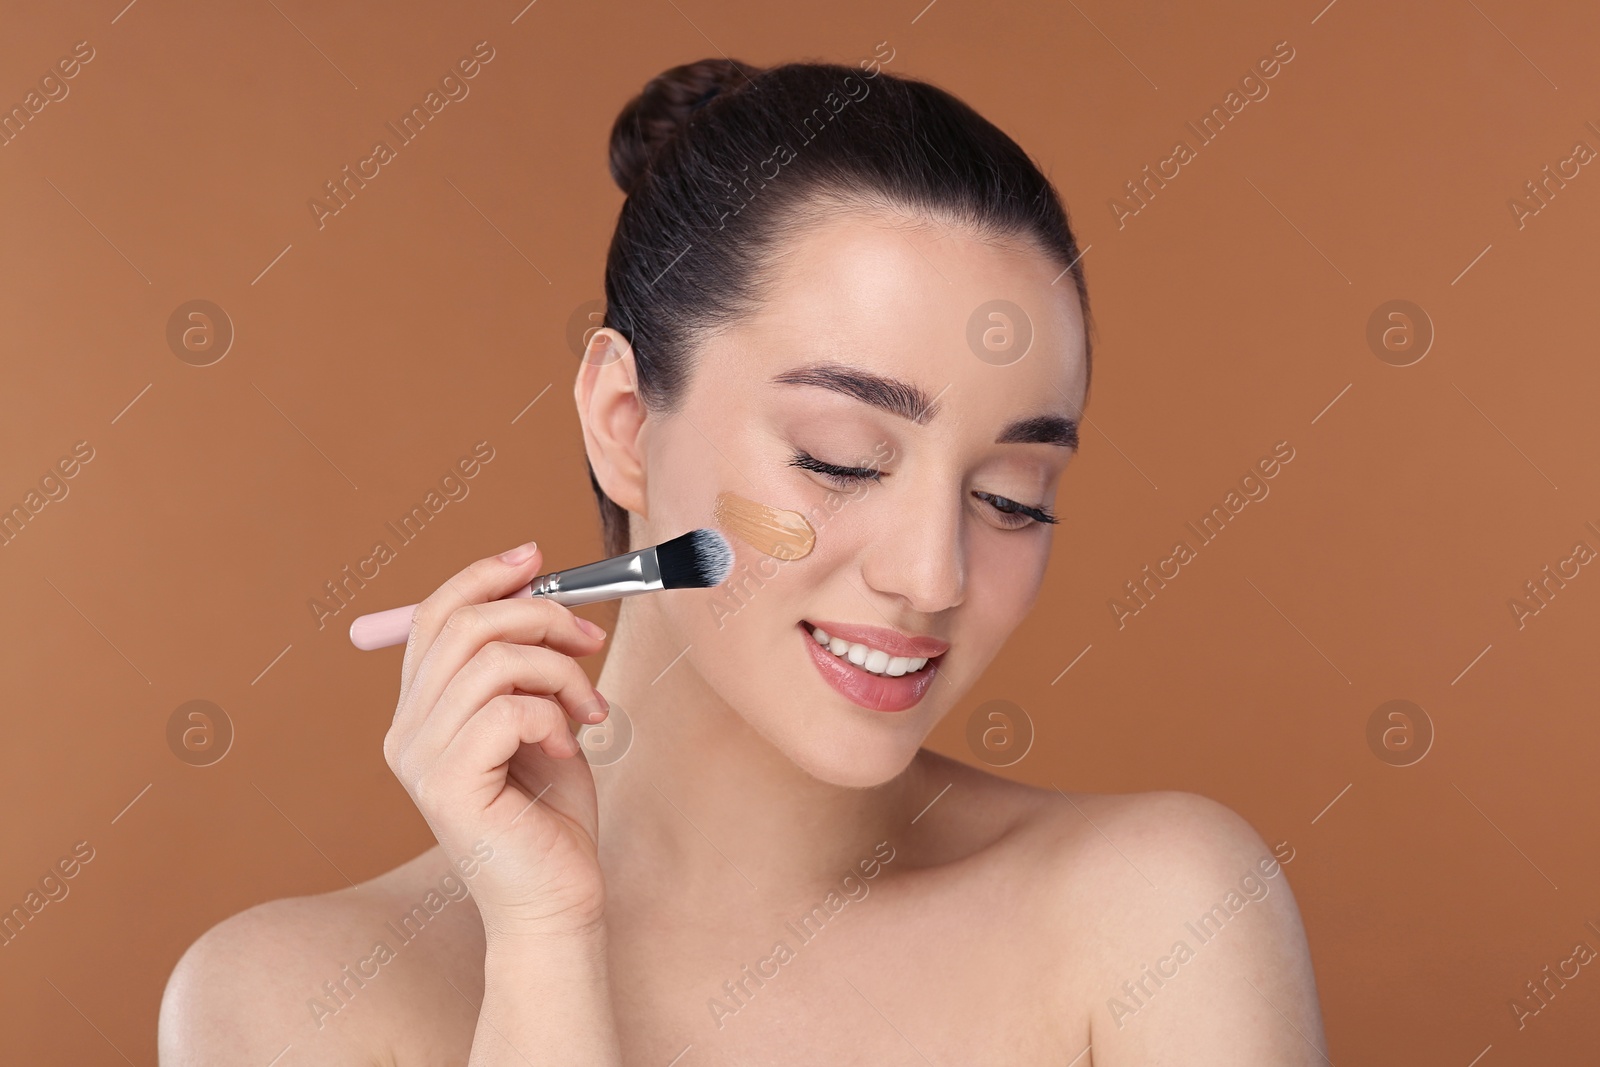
left=160, top=59, right=1325, bottom=1067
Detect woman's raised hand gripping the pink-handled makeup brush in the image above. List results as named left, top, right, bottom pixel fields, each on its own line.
left=384, top=544, right=610, bottom=941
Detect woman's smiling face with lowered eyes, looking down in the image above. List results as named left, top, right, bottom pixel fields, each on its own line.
left=632, top=211, right=1086, bottom=785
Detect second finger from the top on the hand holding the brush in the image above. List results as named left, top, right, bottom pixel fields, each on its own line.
left=392, top=597, right=603, bottom=742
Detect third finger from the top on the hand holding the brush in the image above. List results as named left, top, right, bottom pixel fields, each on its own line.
left=406, top=641, right=605, bottom=766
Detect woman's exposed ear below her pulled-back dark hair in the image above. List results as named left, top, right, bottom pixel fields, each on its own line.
left=573, top=326, right=650, bottom=518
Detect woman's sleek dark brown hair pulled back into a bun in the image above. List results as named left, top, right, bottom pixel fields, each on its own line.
left=589, top=58, right=1090, bottom=555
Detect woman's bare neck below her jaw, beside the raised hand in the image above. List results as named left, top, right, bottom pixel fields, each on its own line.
left=594, top=597, right=923, bottom=899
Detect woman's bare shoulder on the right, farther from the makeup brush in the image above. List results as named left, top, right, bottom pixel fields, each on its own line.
left=908, top=757, right=1326, bottom=1067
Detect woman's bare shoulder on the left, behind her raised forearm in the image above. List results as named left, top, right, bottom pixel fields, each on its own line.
left=158, top=849, right=482, bottom=1067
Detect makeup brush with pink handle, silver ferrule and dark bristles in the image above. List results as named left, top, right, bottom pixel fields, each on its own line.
left=350, top=528, right=733, bottom=649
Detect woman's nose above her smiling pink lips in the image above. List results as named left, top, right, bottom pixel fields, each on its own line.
left=861, top=491, right=966, bottom=614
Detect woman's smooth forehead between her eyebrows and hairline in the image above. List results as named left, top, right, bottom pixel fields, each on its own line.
left=714, top=210, right=1086, bottom=416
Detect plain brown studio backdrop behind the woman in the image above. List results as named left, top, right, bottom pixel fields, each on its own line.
left=0, top=0, right=1600, bottom=1067
